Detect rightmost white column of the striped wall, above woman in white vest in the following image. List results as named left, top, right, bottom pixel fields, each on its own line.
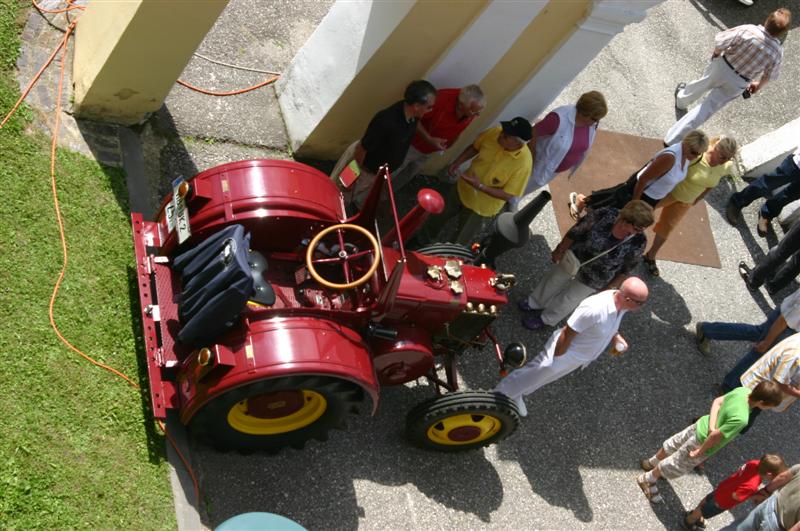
left=493, top=0, right=663, bottom=123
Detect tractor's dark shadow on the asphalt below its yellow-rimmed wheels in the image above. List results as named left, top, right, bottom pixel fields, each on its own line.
left=192, top=386, right=503, bottom=529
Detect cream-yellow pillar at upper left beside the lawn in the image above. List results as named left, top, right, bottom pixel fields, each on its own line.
left=73, top=0, right=228, bottom=124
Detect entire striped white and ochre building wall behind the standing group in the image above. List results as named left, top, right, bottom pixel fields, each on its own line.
left=277, top=0, right=661, bottom=162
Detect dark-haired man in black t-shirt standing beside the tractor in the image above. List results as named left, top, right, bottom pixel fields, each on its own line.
left=337, top=80, right=436, bottom=209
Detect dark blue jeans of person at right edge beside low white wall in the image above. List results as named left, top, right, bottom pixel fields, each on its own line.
left=731, top=154, right=800, bottom=219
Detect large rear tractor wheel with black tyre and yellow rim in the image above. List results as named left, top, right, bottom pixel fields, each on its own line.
left=189, top=375, right=364, bottom=452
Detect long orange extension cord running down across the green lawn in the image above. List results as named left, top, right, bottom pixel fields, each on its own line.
left=0, top=0, right=203, bottom=507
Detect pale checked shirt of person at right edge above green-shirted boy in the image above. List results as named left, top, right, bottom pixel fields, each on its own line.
left=741, top=334, right=800, bottom=412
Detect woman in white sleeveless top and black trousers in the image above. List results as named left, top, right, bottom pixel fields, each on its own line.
left=569, top=129, right=708, bottom=219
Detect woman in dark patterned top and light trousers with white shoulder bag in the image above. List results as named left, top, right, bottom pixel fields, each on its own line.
left=518, top=200, right=653, bottom=330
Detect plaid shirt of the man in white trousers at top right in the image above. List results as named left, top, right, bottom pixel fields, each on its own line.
left=714, top=24, right=783, bottom=82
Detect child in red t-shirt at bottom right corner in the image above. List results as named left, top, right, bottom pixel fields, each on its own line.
left=683, top=454, right=788, bottom=531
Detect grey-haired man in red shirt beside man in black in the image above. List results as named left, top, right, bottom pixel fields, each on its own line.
left=392, top=85, right=486, bottom=191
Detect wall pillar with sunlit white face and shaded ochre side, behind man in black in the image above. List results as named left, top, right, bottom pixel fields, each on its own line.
left=277, top=0, right=488, bottom=158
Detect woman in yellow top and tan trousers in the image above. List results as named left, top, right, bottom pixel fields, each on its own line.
left=642, top=136, right=737, bottom=276
